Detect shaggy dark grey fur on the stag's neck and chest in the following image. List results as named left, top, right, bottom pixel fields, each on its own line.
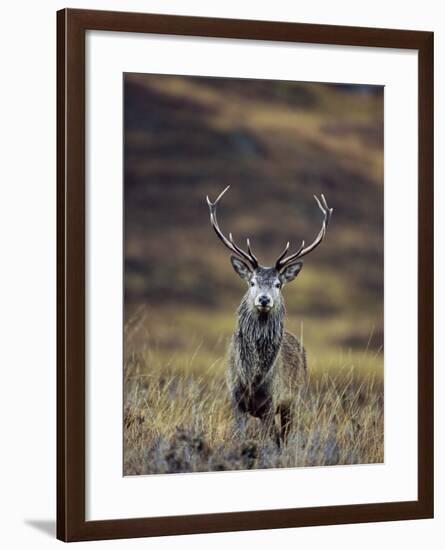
left=235, top=298, right=285, bottom=383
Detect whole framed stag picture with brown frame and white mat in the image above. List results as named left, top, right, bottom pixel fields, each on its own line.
left=57, top=9, right=433, bottom=541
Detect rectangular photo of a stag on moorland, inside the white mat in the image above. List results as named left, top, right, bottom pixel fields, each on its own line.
left=123, top=73, right=384, bottom=476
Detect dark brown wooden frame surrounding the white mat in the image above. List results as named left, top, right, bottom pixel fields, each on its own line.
left=57, top=9, right=433, bottom=541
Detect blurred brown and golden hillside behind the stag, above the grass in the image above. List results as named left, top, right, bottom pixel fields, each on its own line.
left=124, top=74, right=383, bottom=380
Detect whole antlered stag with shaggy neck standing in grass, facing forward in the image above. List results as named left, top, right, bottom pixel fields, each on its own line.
left=206, top=186, right=333, bottom=447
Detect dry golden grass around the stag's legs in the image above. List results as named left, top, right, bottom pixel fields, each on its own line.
left=124, top=329, right=383, bottom=475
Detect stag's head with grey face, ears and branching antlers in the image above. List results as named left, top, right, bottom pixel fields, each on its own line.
left=207, top=186, right=333, bottom=314
